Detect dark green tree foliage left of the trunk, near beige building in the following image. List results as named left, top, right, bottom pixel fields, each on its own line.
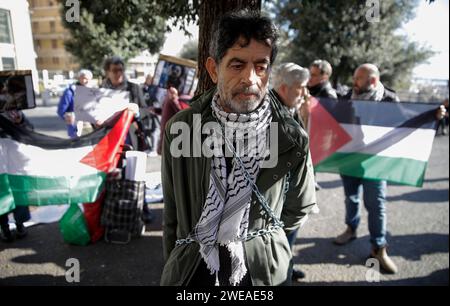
left=61, top=0, right=167, bottom=73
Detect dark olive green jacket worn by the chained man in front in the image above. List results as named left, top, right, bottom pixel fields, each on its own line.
left=161, top=88, right=316, bottom=286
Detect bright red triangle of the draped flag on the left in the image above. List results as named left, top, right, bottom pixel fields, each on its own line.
left=80, top=110, right=134, bottom=172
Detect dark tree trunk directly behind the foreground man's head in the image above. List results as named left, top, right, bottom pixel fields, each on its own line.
left=195, top=0, right=261, bottom=95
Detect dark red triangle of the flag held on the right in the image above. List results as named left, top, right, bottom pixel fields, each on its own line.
left=309, top=98, right=352, bottom=165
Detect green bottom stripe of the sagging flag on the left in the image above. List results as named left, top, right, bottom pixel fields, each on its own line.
left=0, top=172, right=106, bottom=214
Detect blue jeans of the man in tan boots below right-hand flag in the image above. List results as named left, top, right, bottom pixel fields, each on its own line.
left=341, top=175, right=387, bottom=248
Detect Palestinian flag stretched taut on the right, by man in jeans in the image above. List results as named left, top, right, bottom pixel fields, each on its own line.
left=309, top=98, right=438, bottom=187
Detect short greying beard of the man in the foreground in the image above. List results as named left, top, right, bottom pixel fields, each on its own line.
left=221, top=86, right=264, bottom=114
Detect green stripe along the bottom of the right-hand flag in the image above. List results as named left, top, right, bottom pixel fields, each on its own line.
left=315, top=153, right=427, bottom=187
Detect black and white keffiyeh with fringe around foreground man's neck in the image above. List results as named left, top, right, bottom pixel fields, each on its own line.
left=190, top=93, right=272, bottom=285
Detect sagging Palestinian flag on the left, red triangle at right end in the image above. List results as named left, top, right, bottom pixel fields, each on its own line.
left=0, top=110, right=133, bottom=215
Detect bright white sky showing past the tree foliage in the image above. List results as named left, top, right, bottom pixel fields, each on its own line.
left=161, top=0, right=449, bottom=80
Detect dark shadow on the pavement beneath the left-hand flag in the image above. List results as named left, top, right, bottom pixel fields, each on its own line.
left=0, top=209, right=163, bottom=286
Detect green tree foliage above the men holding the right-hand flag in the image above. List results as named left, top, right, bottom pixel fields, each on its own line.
left=273, top=0, right=433, bottom=86
